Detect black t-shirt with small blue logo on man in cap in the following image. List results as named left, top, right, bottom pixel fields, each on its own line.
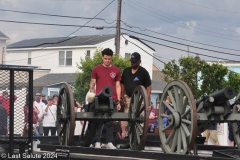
left=121, top=66, right=152, bottom=97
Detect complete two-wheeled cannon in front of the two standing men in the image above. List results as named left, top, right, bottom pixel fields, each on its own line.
left=56, top=83, right=149, bottom=150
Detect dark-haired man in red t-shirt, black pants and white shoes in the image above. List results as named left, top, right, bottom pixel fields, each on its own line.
left=90, top=48, right=121, bottom=149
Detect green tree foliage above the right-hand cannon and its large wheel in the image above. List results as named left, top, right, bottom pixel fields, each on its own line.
left=162, top=57, right=240, bottom=99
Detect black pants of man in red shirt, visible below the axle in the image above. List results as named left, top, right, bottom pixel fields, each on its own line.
left=94, top=121, right=114, bottom=143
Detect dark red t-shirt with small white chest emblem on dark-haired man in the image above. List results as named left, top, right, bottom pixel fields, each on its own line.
left=92, top=64, right=121, bottom=100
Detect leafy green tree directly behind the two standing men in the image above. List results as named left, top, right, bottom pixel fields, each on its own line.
left=73, top=49, right=130, bottom=102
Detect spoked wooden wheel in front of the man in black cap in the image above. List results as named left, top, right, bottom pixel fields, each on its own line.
left=128, top=86, right=149, bottom=150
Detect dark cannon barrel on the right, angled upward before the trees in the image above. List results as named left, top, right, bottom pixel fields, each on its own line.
left=196, top=87, right=236, bottom=106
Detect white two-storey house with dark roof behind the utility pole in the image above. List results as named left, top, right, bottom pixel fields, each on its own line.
left=5, top=34, right=155, bottom=77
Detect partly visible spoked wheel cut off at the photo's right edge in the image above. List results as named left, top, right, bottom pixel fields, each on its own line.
left=232, top=93, right=240, bottom=149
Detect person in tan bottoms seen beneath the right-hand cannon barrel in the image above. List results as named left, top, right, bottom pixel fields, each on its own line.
left=203, top=123, right=220, bottom=146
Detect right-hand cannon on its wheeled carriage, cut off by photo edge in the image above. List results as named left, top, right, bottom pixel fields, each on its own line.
left=158, top=81, right=240, bottom=154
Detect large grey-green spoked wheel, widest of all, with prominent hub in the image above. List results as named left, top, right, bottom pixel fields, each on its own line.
left=158, top=81, right=197, bottom=154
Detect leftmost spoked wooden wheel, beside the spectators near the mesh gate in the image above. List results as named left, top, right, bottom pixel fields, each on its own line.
left=56, top=83, right=75, bottom=146
